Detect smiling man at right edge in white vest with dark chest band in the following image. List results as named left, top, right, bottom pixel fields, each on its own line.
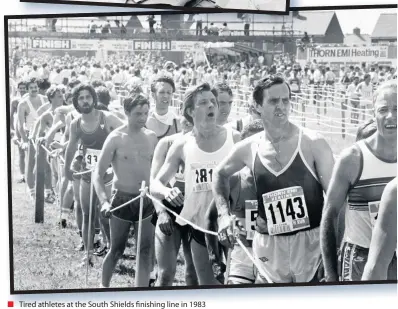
left=321, top=81, right=397, bottom=282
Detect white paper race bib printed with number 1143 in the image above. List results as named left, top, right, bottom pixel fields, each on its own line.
left=263, top=186, right=310, bottom=235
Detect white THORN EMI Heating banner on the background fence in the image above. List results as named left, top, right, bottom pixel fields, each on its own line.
left=307, top=46, right=388, bottom=62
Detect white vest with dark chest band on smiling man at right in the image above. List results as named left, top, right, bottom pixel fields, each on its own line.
left=344, top=140, right=397, bottom=248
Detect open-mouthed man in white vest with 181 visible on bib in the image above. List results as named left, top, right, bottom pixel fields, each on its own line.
left=151, top=83, right=239, bottom=285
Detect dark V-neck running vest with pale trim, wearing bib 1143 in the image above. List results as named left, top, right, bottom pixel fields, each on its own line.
left=252, top=128, right=324, bottom=235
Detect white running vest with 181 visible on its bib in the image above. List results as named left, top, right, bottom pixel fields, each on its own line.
left=176, top=128, right=234, bottom=228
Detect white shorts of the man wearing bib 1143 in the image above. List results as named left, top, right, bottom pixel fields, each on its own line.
left=253, top=227, right=322, bottom=283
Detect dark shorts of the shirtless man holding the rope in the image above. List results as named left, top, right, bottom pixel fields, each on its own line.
left=111, top=190, right=155, bottom=223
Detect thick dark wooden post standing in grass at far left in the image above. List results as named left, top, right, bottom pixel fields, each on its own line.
left=35, top=143, right=46, bottom=223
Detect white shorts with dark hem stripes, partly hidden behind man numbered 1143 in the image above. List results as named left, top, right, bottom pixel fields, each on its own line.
left=228, top=245, right=256, bottom=284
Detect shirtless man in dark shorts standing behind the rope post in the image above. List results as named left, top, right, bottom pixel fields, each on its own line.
left=93, top=94, right=158, bottom=287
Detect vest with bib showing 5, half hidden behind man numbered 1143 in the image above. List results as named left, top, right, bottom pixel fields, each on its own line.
left=231, top=167, right=258, bottom=240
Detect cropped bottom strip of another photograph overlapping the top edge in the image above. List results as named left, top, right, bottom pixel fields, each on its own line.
left=20, top=0, right=290, bottom=14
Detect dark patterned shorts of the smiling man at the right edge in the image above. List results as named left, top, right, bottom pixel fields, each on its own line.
left=338, top=242, right=397, bottom=281
